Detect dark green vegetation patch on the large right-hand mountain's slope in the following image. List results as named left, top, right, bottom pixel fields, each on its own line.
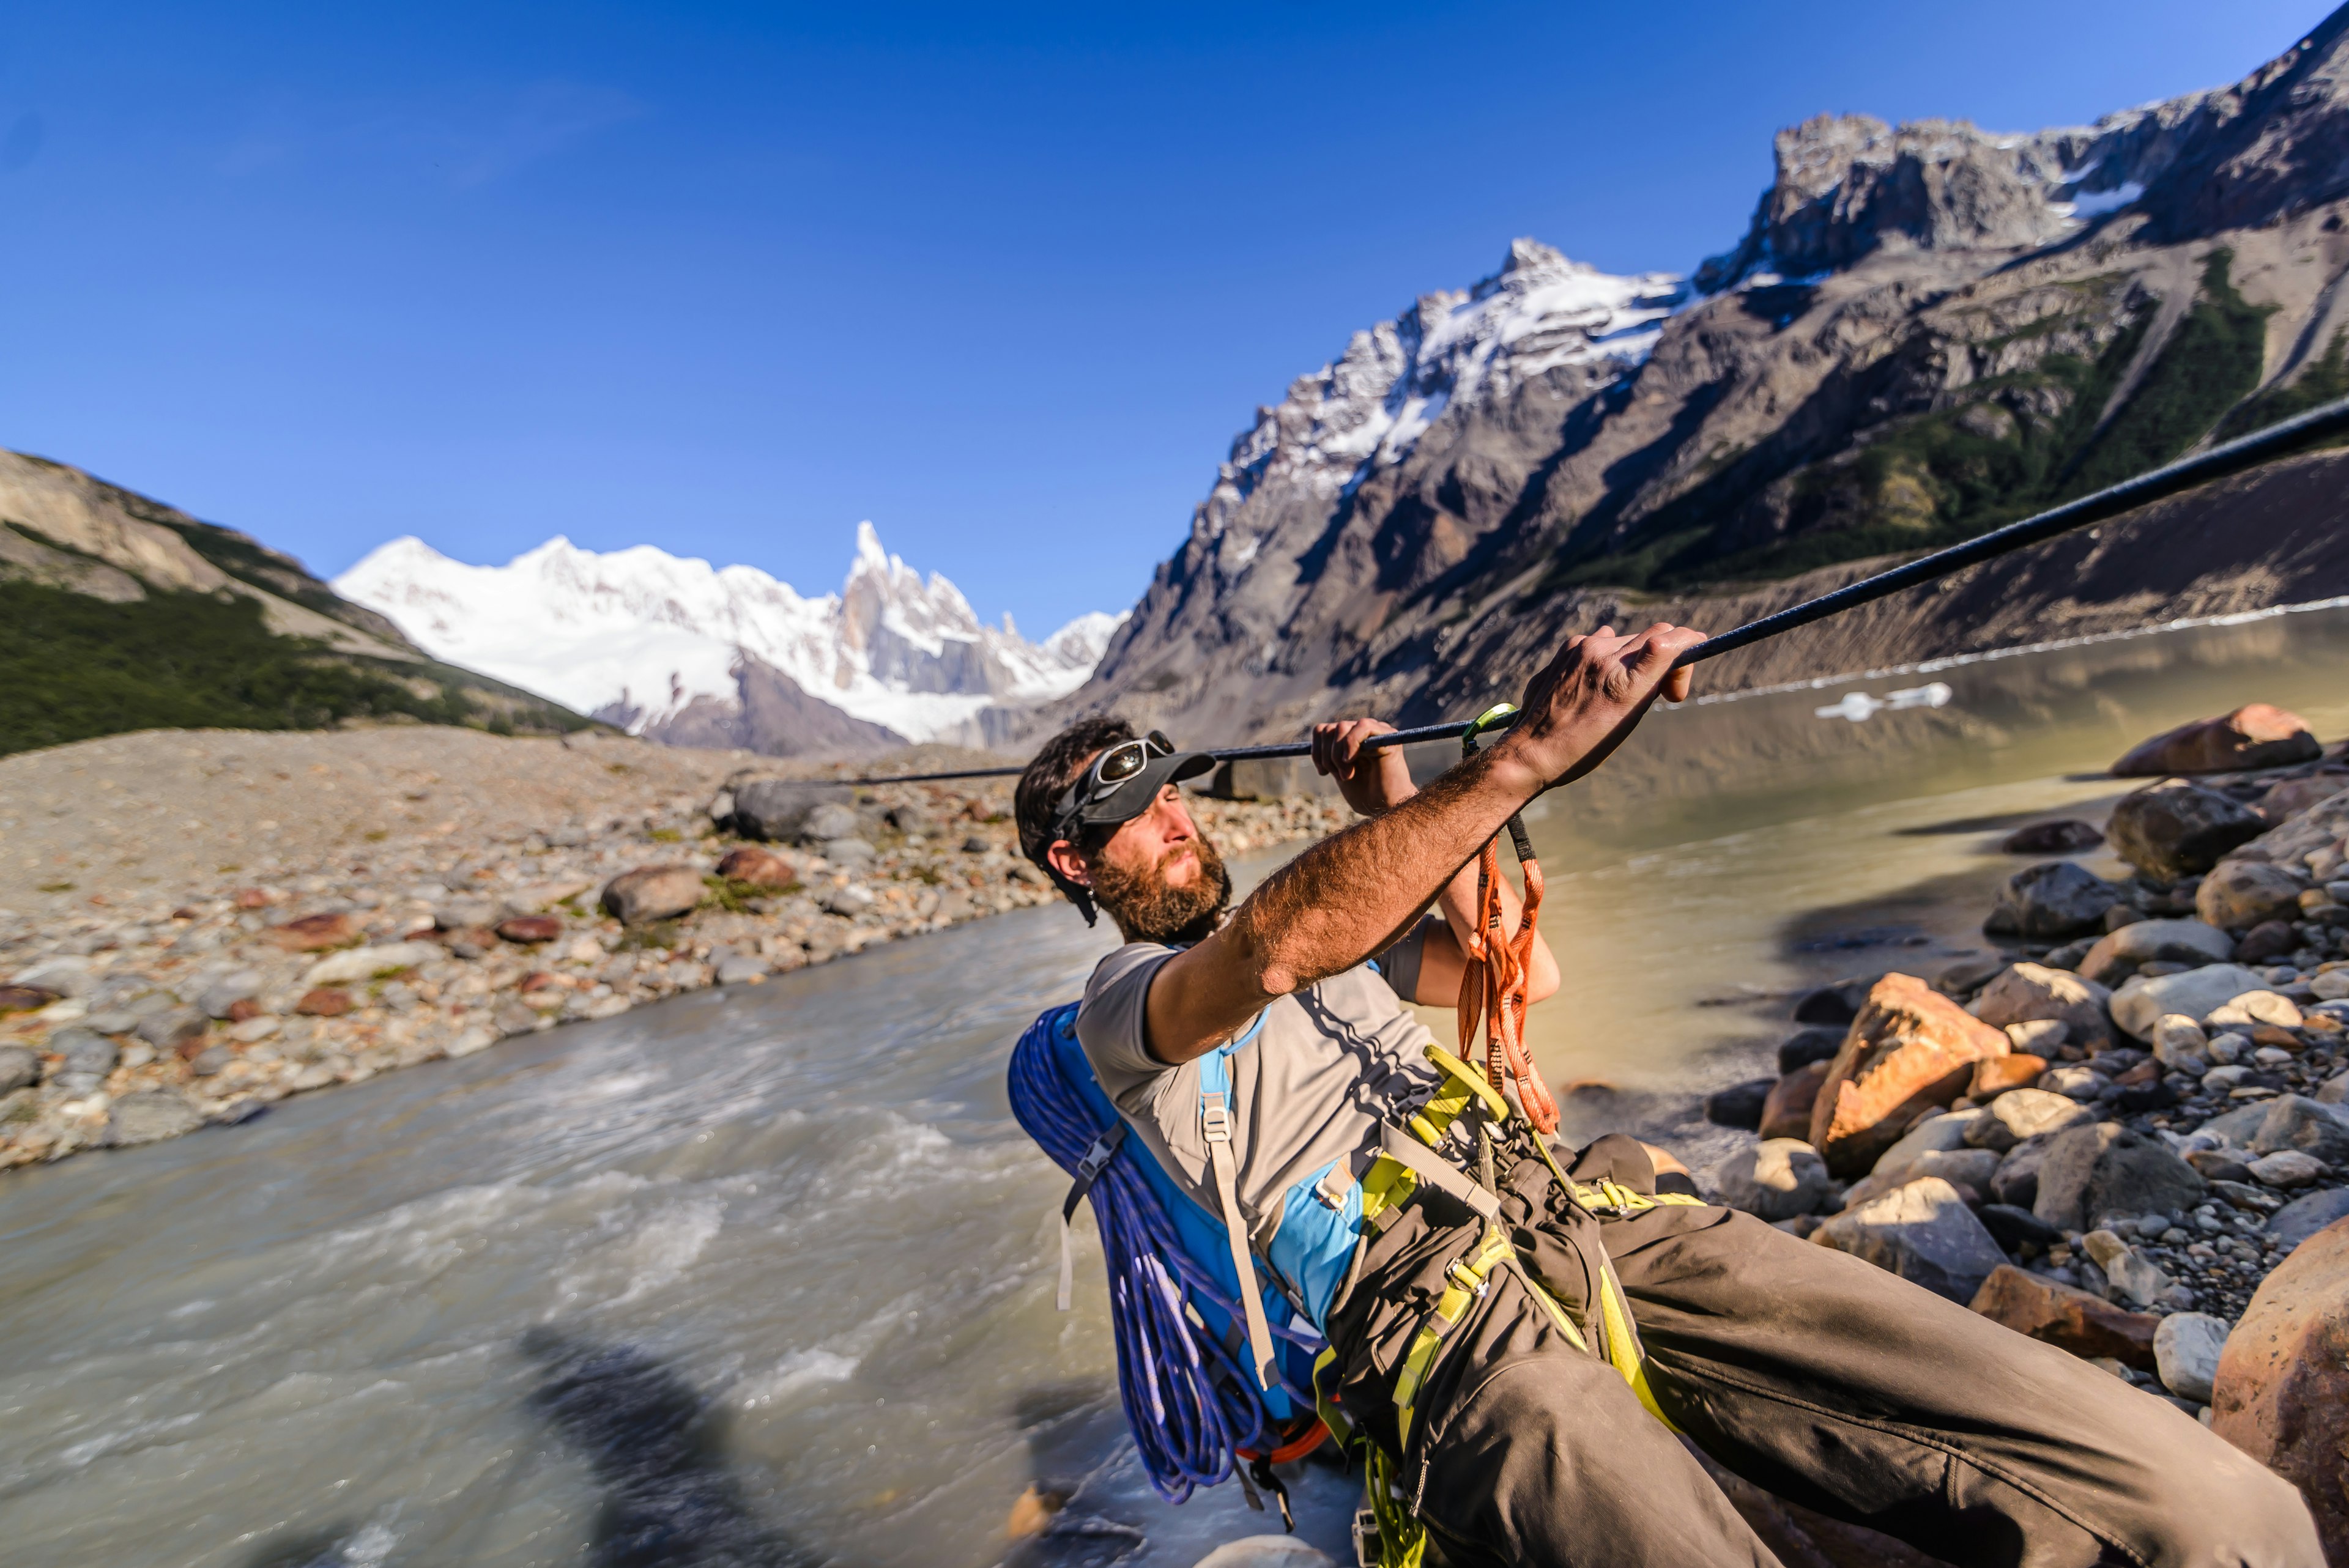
left=1543, top=249, right=2292, bottom=591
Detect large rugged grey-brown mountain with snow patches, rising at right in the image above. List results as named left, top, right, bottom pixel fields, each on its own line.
left=1057, top=9, right=2349, bottom=739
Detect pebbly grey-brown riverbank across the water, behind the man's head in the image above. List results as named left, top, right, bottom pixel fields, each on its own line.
left=0, top=725, right=1341, bottom=1169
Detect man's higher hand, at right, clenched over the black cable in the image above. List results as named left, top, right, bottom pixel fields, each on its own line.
left=1494, top=619, right=1705, bottom=793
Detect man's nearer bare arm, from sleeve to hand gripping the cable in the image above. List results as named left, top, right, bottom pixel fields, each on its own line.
left=1146, top=622, right=1701, bottom=1063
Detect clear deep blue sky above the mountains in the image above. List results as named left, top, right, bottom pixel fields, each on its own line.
left=0, top=0, right=2326, bottom=634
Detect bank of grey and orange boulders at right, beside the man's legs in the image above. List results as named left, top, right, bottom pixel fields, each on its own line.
left=1705, top=706, right=2349, bottom=1549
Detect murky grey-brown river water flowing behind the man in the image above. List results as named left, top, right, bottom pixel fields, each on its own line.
left=0, top=613, right=2349, bottom=1568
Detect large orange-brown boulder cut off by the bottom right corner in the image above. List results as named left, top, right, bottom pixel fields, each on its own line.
left=2210, top=1221, right=2349, bottom=1563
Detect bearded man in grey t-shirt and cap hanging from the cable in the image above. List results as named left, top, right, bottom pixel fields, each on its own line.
left=1017, top=624, right=2323, bottom=1568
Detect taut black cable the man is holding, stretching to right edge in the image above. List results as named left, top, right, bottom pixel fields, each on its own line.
left=812, top=397, right=2349, bottom=784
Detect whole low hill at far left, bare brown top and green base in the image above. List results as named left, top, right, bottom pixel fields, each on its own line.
left=0, top=451, right=587, bottom=751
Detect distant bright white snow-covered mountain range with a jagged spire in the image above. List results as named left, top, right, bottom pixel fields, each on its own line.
left=333, top=523, right=1118, bottom=756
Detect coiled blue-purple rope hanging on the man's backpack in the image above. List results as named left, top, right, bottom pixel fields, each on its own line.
left=1010, top=1002, right=1320, bottom=1503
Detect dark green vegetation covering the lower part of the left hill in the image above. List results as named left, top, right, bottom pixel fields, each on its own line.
left=0, top=580, right=578, bottom=753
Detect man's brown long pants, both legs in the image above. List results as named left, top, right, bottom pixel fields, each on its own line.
left=1329, top=1136, right=2323, bottom=1568
